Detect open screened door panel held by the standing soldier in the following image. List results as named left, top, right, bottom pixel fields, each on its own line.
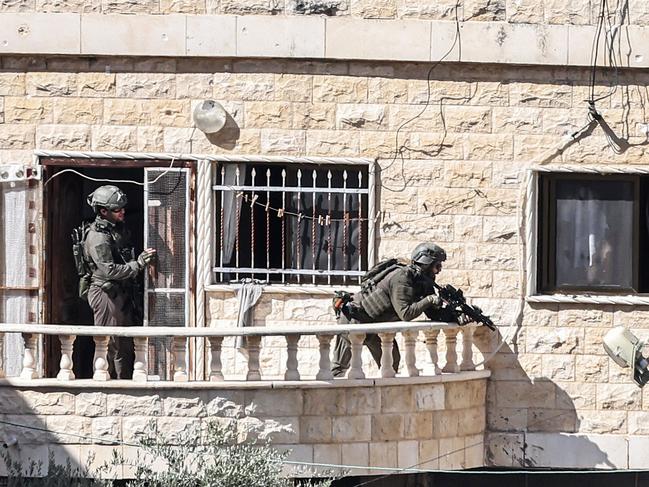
left=144, top=168, right=191, bottom=380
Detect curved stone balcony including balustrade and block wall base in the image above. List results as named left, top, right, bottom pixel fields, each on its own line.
left=0, top=322, right=489, bottom=475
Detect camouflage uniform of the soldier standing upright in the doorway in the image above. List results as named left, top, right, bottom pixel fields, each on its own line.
left=83, top=215, right=140, bottom=379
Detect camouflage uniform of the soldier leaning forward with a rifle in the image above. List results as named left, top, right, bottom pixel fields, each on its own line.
left=331, top=264, right=452, bottom=377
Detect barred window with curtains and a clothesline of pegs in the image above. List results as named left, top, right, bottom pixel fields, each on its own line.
left=219, top=164, right=368, bottom=282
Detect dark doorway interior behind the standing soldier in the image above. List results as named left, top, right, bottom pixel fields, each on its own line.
left=44, top=166, right=144, bottom=379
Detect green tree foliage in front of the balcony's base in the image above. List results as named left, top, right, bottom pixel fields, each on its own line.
left=1, top=422, right=331, bottom=487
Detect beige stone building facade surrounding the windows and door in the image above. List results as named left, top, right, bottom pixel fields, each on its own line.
left=0, top=0, right=649, bottom=476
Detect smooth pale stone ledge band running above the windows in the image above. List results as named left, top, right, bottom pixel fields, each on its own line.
left=0, top=13, right=649, bottom=68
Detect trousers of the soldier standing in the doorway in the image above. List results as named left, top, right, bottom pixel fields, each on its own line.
left=88, top=284, right=137, bottom=379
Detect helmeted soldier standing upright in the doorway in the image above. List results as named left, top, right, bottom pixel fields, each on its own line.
left=80, top=185, right=156, bottom=379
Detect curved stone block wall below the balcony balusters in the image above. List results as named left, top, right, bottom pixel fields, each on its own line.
left=0, top=379, right=486, bottom=476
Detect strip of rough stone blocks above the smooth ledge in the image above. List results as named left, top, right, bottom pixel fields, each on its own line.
left=0, top=0, right=649, bottom=25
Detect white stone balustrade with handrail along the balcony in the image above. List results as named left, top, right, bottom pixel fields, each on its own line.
left=0, top=321, right=476, bottom=383
